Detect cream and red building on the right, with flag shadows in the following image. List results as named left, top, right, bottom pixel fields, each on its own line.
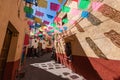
left=55, top=0, right=120, bottom=80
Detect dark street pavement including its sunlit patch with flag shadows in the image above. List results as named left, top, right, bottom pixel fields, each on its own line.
left=17, top=54, right=85, bottom=80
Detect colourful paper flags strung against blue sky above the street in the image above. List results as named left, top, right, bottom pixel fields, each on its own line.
left=24, top=0, right=103, bottom=36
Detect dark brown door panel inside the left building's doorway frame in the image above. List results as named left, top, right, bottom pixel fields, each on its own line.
left=0, top=29, right=13, bottom=80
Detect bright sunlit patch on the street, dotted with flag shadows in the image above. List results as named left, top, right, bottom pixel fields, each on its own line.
left=31, top=61, right=85, bottom=80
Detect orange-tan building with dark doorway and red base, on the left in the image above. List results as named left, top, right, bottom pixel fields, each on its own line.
left=0, top=0, right=28, bottom=80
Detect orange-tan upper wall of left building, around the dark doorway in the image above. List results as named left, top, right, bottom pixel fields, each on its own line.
left=0, top=0, right=28, bottom=62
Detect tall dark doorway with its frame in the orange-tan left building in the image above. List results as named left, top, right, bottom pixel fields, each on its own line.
left=0, top=22, right=18, bottom=80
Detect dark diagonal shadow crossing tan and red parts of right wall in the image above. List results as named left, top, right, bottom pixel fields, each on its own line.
left=72, top=38, right=102, bottom=80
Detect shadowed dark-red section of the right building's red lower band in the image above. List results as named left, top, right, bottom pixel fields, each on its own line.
left=72, top=56, right=102, bottom=80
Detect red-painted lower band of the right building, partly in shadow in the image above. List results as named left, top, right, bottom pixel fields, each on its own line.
left=57, top=53, right=120, bottom=80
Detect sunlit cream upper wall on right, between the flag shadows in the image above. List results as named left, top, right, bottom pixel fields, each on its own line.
left=76, top=0, right=120, bottom=60
